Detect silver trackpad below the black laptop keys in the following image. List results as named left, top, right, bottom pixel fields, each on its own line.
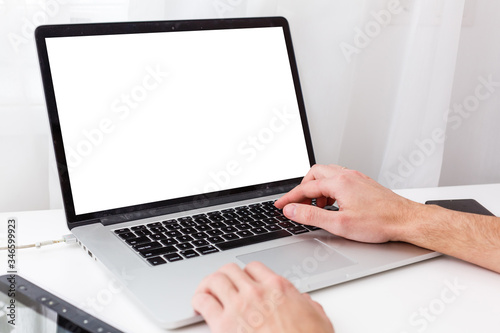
left=236, top=239, right=356, bottom=286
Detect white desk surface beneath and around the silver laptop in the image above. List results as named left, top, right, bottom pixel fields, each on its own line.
left=0, top=184, right=500, bottom=333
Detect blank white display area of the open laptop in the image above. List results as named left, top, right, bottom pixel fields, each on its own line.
left=47, top=27, right=310, bottom=214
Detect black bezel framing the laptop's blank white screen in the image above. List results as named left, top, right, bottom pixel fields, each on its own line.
left=35, top=17, right=315, bottom=229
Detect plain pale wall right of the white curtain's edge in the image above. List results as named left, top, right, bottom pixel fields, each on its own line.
left=440, top=0, right=500, bottom=185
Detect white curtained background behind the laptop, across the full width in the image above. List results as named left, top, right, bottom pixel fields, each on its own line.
left=0, top=0, right=500, bottom=211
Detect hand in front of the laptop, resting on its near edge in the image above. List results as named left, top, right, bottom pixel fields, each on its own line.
left=192, top=262, right=333, bottom=333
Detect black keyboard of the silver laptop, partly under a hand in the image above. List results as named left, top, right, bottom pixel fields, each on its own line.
left=113, top=201, right=319, bottom=266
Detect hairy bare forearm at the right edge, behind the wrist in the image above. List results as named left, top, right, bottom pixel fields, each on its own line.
left=400, top=205, right=500, bottom=273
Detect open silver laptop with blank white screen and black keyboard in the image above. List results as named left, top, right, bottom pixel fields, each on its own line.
left=35, top=17, right=438, bottom=328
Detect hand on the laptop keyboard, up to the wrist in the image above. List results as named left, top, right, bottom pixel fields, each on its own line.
left=275, top=165, right=423, bottom=243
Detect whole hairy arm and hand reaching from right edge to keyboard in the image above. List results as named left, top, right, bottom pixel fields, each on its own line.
left=276, top=165, right=500, bottom=273
